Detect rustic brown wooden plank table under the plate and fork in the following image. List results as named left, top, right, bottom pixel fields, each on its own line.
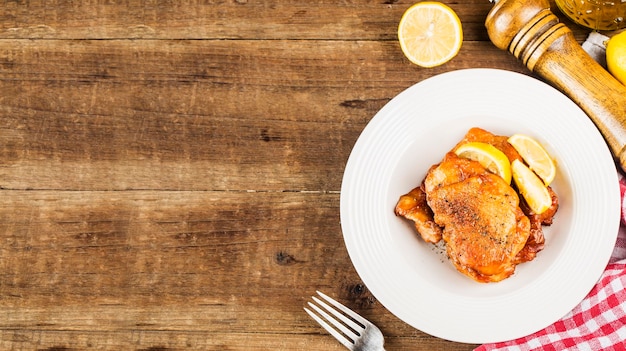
left=0, top=0, right=586, bottom=351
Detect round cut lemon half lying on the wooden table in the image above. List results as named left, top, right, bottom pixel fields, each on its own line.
left=398, top=1, right=463, bottom=67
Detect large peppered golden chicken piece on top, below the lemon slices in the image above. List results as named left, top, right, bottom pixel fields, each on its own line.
left=424, top=153, right=530, bottom=282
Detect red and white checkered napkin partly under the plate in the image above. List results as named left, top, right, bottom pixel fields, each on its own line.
left=474, top=175, right=626, bottom=351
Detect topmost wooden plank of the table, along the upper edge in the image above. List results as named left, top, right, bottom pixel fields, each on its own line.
left=0, top=0, right=490, bottom=40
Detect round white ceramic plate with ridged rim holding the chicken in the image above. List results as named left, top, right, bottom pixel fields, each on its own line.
left=341, top=69, right=620, bottom=343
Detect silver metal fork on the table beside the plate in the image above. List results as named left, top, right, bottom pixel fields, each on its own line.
left=304, top=291, right=385, bottom=351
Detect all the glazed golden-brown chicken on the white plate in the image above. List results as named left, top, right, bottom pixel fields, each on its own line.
left=395, top=128, right=558, bottom=282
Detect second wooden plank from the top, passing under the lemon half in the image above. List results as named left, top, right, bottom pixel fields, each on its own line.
left=0, top=40, right=525, bottom=191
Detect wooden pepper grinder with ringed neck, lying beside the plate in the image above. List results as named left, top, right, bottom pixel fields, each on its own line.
left=485, top=0, right=626, bottom=172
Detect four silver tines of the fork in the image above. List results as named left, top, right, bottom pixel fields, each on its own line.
left=304, top=291, right=371, bottom=349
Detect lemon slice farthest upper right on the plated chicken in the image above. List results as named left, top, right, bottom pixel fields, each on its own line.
left=508, top=134, right=556, bottom=185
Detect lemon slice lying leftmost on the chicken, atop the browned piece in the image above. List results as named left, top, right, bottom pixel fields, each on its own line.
left=454, top=141, right=511, bottom=184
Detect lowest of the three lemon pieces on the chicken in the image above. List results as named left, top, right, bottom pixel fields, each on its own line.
left=511, top=160, right=552, bottom=214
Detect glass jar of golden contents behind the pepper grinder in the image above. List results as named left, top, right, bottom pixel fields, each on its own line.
left=555, top=0, right=626, bottom=30
